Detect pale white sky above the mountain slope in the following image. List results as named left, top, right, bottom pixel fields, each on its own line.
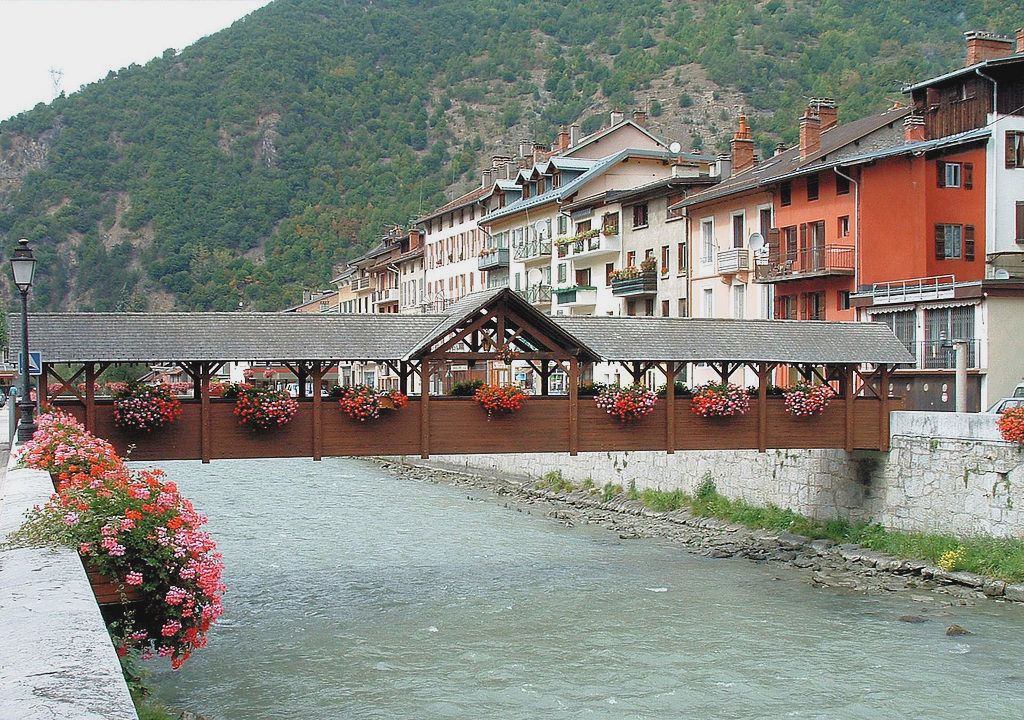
left=0, top=0, right=269, bottom=120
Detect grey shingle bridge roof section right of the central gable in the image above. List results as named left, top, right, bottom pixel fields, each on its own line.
left=554, top=316, right=914, bottom=364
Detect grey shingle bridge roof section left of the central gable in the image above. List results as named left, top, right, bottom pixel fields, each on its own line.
left=11, top=312, right=438, bottom=363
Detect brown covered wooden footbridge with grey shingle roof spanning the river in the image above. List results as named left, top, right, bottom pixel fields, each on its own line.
left=12, top=289, right=913, bottom=462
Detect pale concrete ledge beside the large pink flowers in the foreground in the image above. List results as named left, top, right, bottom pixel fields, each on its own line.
left=0, top=450, right=138, bottom=720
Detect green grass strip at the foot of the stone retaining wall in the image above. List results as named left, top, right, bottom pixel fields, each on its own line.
left=538, top=471, right=1024, bottom=583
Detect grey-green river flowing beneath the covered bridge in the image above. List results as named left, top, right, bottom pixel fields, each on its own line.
left=150, top=459, right=1024, bottom=720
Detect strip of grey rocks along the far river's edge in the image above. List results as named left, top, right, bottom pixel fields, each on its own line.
left=378, top=459, right=1024, bottom=604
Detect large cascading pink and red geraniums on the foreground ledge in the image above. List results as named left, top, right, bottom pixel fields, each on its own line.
left=7, top=413, right=224, bottom=669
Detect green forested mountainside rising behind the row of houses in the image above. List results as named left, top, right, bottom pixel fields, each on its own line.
left=0, top=0, right=1024, bottom=309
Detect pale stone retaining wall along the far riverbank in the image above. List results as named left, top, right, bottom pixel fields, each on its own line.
left=419, top=412, right=1024, bottom=537
